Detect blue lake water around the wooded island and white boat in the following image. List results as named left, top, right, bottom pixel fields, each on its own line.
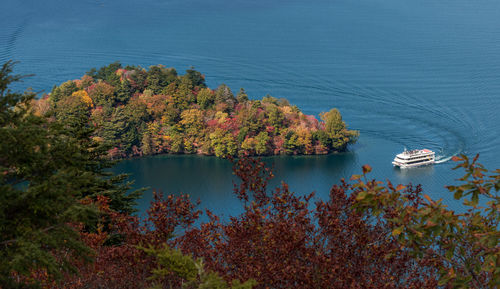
left=0, top=0, right=500, bottom=214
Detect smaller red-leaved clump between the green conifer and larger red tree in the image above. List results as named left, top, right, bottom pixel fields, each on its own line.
left=45, top=193, right=200, bottom=289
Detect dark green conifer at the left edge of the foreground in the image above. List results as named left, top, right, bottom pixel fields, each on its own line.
left=0, top=61, right=141, bottom=289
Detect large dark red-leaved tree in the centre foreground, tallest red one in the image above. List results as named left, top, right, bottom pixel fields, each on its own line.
left=178, top=158, right=437, bottom=288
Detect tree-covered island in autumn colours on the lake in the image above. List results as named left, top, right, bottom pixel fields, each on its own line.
left=33, top=62, right=358, bottom=158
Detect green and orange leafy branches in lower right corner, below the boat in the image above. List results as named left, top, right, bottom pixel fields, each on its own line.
left=355, top=155, right=500, bottom=288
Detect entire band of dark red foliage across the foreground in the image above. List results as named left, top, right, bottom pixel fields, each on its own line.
left=43, top=157, right=437, bottom=288
